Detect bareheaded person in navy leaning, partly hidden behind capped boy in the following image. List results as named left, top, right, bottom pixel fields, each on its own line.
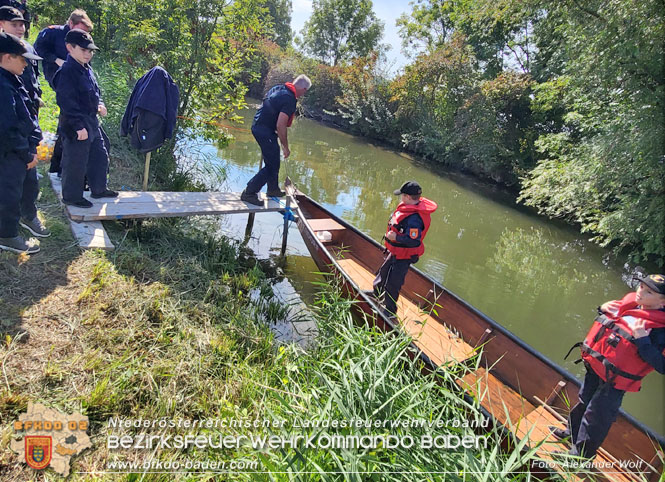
left=35, top=9, right=93, bottom=174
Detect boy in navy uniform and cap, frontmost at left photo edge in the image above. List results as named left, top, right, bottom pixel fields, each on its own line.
left=0, top=32, right=45, bottom=254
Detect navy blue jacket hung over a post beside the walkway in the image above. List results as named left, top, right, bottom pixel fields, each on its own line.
left=120, top=67, right=180, bottom=138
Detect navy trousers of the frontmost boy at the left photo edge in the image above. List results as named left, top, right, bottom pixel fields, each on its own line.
left=0, top=153, right=39, bottom=238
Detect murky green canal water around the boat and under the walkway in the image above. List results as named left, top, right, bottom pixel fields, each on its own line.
left=189, top=108, right=665, bottom=434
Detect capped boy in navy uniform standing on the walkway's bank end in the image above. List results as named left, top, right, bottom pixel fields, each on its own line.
left=53, top=29, right=118, bottom=208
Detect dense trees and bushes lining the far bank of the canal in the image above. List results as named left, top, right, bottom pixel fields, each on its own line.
left=262, top=0, right=665, bottom=264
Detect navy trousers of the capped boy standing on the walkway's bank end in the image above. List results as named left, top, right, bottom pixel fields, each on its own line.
left=62, top=117, right=109, bottom=201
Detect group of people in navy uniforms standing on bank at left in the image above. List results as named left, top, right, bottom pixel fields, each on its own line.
left=0, top=4, right=118, bottom=254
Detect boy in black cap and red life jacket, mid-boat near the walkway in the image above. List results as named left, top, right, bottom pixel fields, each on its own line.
left=373, top=181, right=437, bottom=316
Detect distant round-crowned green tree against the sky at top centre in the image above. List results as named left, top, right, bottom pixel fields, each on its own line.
left=302, top=0, right=383, bottom=65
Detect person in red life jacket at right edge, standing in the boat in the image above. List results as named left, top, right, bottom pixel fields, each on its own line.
left=553, top=274, right=665, bottom=458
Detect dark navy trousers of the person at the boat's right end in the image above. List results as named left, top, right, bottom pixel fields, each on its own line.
left=568, top=367, right=626, bottom=458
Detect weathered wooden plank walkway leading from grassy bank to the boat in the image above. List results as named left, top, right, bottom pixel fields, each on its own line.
left=67, top=191, right=286, bottom=221
